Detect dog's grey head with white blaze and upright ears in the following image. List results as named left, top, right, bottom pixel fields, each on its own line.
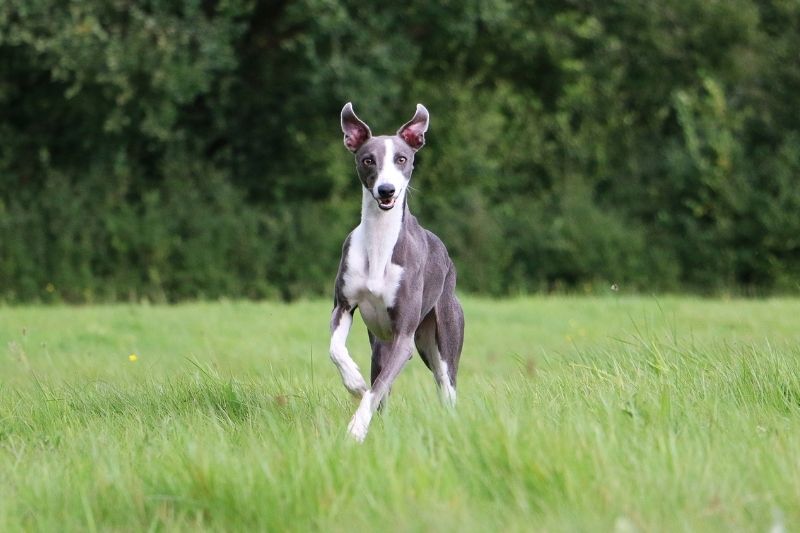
left=342, top=102, right=428, bottom=211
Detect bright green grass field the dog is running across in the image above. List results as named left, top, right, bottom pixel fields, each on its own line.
left=0, top=297, right=800, bottom=532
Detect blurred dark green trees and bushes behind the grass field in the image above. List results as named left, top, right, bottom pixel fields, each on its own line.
left=0, top=0, right=800, bottom=302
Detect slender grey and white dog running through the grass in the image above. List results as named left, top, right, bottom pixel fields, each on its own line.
left=330, top=103, right=464, bottom=442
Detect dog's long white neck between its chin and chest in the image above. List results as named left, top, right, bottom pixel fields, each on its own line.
left=361, top=187, right=408, bottom=278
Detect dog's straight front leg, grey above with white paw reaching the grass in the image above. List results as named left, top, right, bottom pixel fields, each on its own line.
left=347, top=335, right=413, bottom=442
